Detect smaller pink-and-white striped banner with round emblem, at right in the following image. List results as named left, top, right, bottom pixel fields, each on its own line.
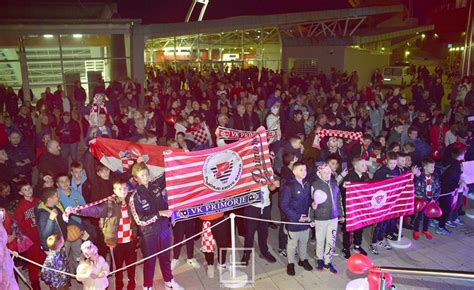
left=344, top=172, right=415, bottom=232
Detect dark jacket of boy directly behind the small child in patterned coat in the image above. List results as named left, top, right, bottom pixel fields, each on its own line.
left=35, top=202, right=67, bottom=251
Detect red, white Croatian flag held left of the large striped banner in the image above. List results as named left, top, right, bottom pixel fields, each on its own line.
left=89, top=137, right=183, bottom=179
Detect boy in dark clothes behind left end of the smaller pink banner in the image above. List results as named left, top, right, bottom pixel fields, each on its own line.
left=341, top=156, right=369, bottom=259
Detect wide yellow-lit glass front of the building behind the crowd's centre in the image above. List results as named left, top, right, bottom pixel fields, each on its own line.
left=145, top=28, right=281, bottom=70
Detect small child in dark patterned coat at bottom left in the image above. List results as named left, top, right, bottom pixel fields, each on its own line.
left=41, top=234, right=70, bottom=290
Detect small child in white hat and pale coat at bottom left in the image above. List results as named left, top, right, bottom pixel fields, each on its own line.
left=76, top=241, right=109, bottom=290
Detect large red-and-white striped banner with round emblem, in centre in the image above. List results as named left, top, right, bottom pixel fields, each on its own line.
left=165, top=127, right=273, bottom=211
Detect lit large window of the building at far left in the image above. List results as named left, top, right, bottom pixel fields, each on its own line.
left=0, top=34, right=130, bottom=100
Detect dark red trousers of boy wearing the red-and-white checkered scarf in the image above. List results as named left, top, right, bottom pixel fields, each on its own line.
left=113, top=240, right=137, bottom=290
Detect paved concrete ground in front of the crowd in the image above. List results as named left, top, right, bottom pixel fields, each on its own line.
left=21, top=198, right=474, bottom=290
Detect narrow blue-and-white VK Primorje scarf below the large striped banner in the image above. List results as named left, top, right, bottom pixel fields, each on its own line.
left=171, top=190, right=263, bottom=223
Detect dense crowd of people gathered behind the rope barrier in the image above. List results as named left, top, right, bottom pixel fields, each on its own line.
left=0, top=67, right=474, bottom=289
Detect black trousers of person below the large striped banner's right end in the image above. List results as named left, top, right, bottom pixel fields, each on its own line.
left=244, top=206, right=271, bottom=254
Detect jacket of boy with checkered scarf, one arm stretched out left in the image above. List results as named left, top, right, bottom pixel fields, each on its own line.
left=73, top=195, right=138, bottom=247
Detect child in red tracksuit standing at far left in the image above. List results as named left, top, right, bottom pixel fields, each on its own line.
left=14, top=180, right=46, bottom=290
